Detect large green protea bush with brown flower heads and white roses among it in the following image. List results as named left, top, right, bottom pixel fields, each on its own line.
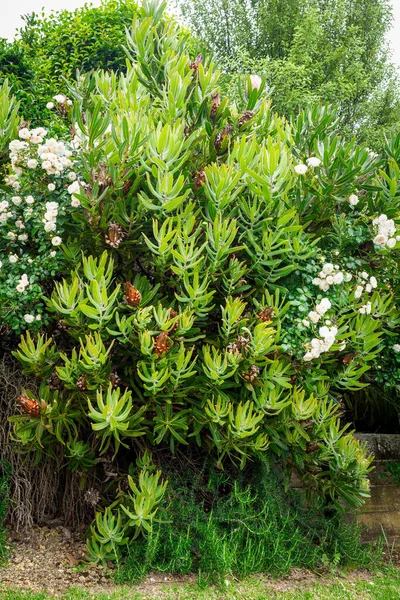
left=5, top=1, right=400, bottom=561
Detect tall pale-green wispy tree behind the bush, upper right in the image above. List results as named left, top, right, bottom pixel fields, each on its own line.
left=179, top=0, right=400, bottom=148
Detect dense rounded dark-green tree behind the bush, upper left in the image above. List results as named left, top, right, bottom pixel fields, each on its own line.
left=0, top=0, right=137, bottom=125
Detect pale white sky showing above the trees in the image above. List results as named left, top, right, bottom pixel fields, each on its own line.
left=0, top=0, right=400, bottom=66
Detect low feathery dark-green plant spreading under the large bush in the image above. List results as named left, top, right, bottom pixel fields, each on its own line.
left=117, top=460, right=380, bottom=583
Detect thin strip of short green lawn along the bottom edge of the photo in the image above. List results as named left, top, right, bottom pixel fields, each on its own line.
left=0, top=569, right=400, bottom=600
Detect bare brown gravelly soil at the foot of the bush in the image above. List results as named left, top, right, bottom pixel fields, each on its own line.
left=0, top=525, right=392, bottom=599
